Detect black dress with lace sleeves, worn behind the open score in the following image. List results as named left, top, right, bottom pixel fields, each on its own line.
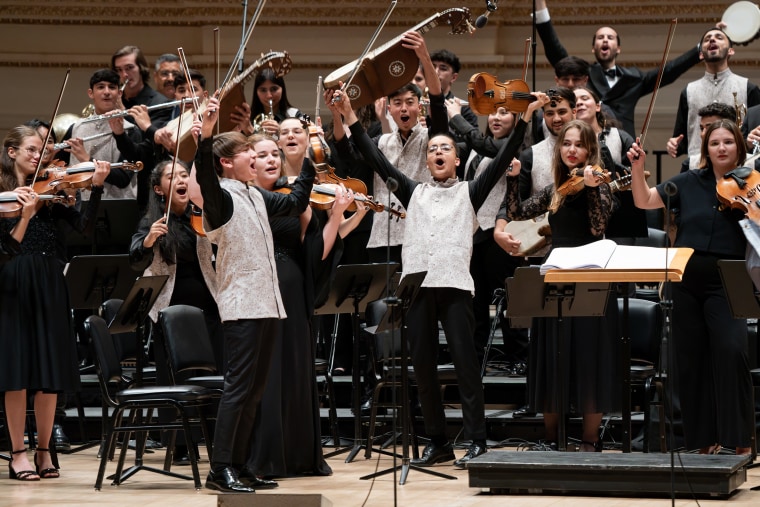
left=500, top=178, right=621, bottom=414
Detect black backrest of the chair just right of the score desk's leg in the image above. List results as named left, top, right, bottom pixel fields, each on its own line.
left=618, top=298, right=663, bottom=366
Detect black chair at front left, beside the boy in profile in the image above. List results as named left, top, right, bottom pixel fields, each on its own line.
left=84, top=315, right=212, bottom=490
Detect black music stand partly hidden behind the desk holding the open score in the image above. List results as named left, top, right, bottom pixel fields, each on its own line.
left=507, top=266, right=610, bottom=451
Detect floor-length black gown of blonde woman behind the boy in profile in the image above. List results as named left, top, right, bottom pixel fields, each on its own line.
left=247, top=217, right=332, bottom=477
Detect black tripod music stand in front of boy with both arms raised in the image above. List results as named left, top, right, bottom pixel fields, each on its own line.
left=360, top=271, right=456, bottom=486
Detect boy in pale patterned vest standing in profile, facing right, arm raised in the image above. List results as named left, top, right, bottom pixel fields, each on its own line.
left=194, top=98, right=315, bottom=493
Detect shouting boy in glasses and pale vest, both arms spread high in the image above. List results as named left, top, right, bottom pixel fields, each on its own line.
left=328, top=83, right=549, bottom=468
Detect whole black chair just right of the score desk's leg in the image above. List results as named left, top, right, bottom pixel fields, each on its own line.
left=618, top=298, right=667, bottom=452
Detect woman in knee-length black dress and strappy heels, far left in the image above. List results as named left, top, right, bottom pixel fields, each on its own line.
left=0, top=126, right=110, bottom=481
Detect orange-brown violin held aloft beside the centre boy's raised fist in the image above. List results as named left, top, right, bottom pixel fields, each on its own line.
left=467, top=72, right=536, bottom=116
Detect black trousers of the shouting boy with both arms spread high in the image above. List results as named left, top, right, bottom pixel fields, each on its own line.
left=407, top=287, right=486, bottom=440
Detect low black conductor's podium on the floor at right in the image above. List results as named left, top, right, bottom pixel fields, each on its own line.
left=467, top=451, right=749, bottom=497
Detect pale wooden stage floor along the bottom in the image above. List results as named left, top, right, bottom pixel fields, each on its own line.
left=0, top=448, right=760, bottom=507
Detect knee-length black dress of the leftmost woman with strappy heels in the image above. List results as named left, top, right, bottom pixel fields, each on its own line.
left=0, top=194, right=102, bottom=393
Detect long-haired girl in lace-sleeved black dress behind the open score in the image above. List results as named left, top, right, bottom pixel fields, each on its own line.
left=497, top=120, right=620, bottom=451
